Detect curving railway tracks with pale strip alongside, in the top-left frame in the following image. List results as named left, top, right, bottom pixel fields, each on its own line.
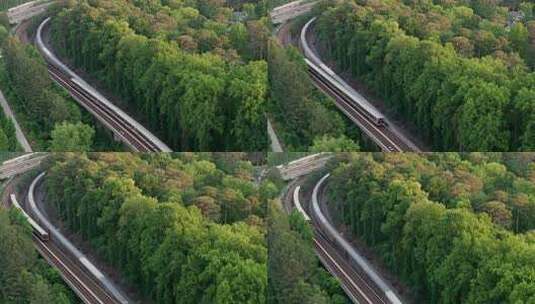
left=36, top=18, right=171, bottom=152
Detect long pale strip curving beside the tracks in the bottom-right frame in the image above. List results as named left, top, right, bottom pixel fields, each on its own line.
left=312, top=173, right=402, bottom=304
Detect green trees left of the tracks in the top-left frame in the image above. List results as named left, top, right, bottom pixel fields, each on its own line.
left=0, top=21, right=121, bottom=151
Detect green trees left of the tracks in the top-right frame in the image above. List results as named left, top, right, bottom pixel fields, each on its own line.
left=268, top=39, right=359, bottom=152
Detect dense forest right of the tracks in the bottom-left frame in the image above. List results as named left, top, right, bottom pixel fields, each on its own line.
left=45, top=153, right=278, bottom=304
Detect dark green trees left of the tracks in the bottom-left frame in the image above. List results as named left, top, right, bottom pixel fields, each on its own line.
left=0, top=206, right=79, bottom=304
